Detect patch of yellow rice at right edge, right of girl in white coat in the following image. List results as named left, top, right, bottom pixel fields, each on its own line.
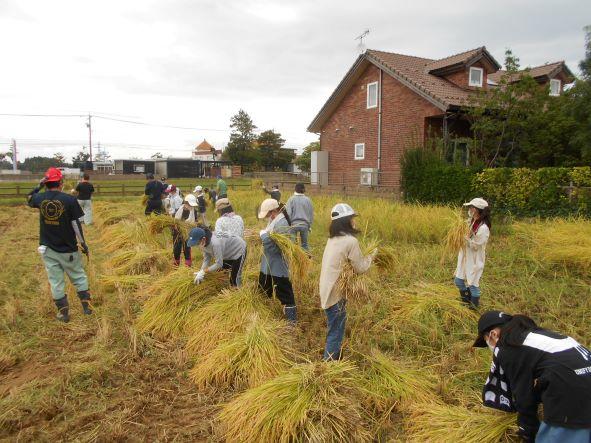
left=515, top=219, right=591, bottom=275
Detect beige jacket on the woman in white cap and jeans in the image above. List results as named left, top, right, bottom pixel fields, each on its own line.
left=320, top=235, right=371, bottom=309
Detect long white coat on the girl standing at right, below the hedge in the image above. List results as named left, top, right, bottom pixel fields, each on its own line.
left=455, top=223, right=490, bottom=286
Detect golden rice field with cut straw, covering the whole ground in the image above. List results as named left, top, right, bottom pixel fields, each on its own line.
left=0, top=191, right=591, bottom=442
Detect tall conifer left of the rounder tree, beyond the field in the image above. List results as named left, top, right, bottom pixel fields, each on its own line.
left=222, top=109, right=257, bottom=170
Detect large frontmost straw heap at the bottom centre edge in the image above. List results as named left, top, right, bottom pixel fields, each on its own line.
left=220, top=361, right=373, bottom=443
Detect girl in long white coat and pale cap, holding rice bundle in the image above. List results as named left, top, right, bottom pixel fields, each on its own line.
left=454, top=198, right=491, bottom=309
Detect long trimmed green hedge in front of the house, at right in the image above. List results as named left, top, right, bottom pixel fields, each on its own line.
left=402, top=149, right=591, bottom=217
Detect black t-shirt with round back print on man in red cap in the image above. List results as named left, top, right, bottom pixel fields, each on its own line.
left=29, top=191, right=84, bottom=252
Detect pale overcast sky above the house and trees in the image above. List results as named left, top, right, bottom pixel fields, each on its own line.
left=0, top=0, right=591, bottom=158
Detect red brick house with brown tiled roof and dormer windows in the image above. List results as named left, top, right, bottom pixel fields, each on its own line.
left=308, top=46, right=573, bottom=190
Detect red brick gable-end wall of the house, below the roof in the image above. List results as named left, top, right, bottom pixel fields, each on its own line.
left=320, top=65, right=442, bottom=189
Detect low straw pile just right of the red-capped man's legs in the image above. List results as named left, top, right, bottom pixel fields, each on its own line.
left=105, top=244, right=170, bottom=275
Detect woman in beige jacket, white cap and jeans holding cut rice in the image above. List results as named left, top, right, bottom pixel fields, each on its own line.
left=320, top=203, right=377, bottom=361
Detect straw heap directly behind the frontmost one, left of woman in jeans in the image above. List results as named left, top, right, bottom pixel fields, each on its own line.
left=190, top=314, right=291, bottom=389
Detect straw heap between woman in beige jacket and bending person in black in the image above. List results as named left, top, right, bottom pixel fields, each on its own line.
left=377, top=284, right=478, bottom=355
